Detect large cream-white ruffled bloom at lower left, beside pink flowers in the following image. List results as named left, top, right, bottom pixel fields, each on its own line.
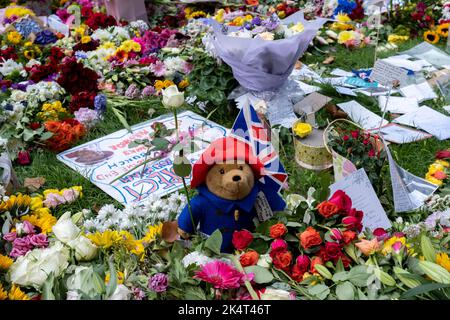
left=9, top=242, right=69, bottom=290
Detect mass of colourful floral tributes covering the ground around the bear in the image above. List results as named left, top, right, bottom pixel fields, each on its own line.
left=0, top=0, right=450, bottom=300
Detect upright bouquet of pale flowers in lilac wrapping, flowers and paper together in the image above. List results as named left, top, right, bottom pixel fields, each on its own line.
left=212, top=12, right=326, bottom=91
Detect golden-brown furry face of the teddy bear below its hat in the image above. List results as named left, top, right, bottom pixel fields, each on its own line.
left=206, top=162, right=255, bottom=200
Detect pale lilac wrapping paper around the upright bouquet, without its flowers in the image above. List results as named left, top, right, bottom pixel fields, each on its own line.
left=212, top=11, right=327, bottom=91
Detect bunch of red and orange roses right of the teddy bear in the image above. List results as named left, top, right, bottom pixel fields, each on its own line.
left=232, top=190, right=363, bottom=282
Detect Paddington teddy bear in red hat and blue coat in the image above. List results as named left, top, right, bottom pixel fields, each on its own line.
left=178, top=137, right=285, bottom=252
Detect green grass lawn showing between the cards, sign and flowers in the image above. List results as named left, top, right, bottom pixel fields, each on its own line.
left=15, top=41, right=450, bottom=216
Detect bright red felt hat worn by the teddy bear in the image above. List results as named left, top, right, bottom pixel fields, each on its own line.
left=191, top=137, right=264, bottom=189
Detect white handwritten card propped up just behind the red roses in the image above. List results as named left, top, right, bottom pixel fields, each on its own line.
left=330, top=168, right=391, bottom=230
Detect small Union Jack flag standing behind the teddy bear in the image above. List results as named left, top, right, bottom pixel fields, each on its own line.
left=230, top=104, right=287, bottom=192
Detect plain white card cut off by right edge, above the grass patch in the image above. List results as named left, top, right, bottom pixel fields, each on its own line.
left=394, top=106, right=450, bottom=140
